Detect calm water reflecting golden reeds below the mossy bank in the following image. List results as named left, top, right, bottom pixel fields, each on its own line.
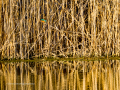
left=0, top=60, right=120, bottom=90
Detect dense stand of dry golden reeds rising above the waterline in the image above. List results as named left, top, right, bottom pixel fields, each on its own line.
left=0, top=0, right=120, bottom=59
